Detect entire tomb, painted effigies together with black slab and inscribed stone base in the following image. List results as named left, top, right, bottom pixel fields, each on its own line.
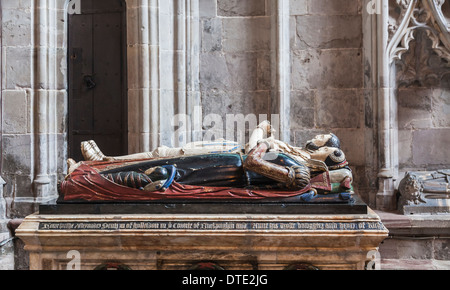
left=17, top=127, right=388, bottom=270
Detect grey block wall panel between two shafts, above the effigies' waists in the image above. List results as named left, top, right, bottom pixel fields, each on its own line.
left=200, top=0, right=271, bottom=138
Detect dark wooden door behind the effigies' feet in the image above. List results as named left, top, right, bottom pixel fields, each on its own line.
left=68, top=0, right=128, bottom=161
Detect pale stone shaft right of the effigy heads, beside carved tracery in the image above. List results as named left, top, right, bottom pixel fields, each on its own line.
left=362, top=0, right=398, bottom=210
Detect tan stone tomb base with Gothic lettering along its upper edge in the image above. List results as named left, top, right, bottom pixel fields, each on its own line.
left=17, top=210, right=388, bottom=270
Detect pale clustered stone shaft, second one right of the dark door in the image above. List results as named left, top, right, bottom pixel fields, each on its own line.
left=167, top=0, right=201, bottom=147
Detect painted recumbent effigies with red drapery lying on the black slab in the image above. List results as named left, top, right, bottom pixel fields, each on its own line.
left=58, top=121, right=353, bottom=202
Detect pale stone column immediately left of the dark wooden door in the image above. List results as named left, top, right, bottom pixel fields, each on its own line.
left=30, top=0, right=58, bottom=203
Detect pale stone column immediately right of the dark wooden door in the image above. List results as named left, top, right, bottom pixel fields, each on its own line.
left=127, top=0, right=160, bottom=152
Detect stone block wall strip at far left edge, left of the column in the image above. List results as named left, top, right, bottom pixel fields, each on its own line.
left=2, top=1, right=32, bottom=219
